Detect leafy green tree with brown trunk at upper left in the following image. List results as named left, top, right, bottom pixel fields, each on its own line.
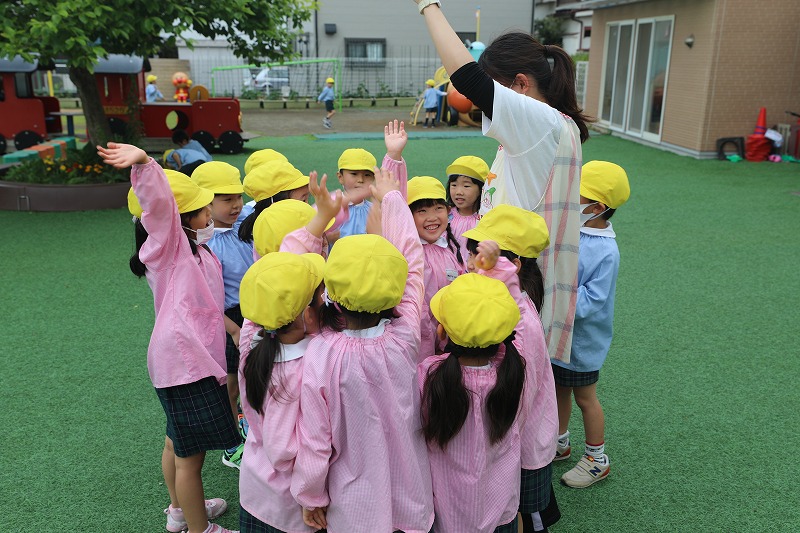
left=0, top=0, right=315, bottom=143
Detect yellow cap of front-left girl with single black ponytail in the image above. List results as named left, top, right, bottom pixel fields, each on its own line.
left=239, top=252, right=325, bottom=330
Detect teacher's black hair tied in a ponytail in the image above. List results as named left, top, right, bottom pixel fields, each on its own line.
left=478, top=32, right=594, bottom=143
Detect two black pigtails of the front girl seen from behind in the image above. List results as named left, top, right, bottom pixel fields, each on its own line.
left=422, top=333, right=525, bottom=450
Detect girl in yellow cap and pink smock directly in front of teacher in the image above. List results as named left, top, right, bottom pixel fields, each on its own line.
left=464, top=205, right=561, bottom=531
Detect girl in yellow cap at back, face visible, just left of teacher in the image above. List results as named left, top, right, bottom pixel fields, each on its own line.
left=445, top=155, right=490, bottom=260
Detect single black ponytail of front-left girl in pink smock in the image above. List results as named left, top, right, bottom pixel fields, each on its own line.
left=242, top=322, right=292, bottom=415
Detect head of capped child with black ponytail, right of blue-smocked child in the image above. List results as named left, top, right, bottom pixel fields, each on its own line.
left=239, top=158, right=308, bottom=242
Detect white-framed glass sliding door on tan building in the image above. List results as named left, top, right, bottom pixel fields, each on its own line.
left=600, top=17, right=673, bottom=142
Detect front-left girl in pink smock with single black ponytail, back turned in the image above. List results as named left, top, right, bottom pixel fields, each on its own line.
left=239, top=250, right=325, bottom=533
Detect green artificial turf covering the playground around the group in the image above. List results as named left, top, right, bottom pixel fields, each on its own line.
left=0, top=132, right=800, bottom=532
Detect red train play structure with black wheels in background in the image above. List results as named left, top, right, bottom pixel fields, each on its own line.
left=0, top=54, right=245, bottom=154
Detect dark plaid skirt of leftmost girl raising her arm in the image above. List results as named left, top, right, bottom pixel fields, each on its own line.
left=156, top=377, right=241, bottom=457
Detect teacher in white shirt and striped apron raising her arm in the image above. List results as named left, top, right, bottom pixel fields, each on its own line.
left=414, top=0, right=589, bottom=361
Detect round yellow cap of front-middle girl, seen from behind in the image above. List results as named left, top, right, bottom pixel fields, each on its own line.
left=325, top=235, right=408, bottom=313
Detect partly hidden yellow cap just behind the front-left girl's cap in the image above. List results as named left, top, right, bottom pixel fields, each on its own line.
left=253, top=200, right=334, bottom=257
